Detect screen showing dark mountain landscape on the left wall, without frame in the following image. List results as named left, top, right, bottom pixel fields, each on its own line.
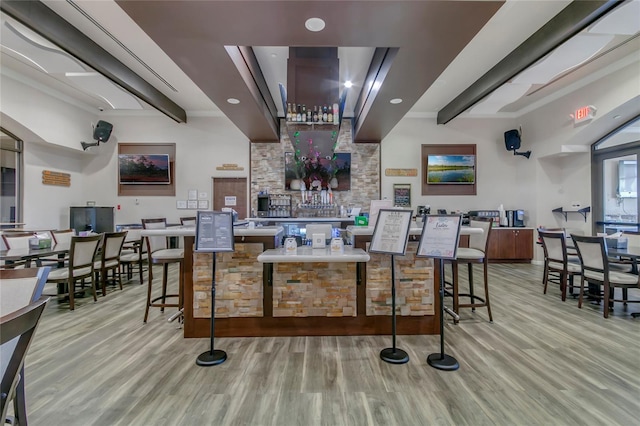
left=118, top=154, right=171, bottom=185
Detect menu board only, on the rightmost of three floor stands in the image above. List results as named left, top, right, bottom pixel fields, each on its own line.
left=417, top=215, right=462, bottom=259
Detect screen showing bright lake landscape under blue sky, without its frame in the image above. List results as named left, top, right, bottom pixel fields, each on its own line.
left=427, top=155, right=476, bottom=184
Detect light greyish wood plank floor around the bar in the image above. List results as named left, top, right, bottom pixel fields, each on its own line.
left=15, top=264, right=640, bottom=426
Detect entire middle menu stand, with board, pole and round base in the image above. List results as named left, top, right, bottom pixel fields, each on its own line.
left=369, top=208, right=413, bottom=364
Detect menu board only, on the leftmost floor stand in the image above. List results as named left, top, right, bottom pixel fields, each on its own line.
left=195, top=211, right=234, bottom=253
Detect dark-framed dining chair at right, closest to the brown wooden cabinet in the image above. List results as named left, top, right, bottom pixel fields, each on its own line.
left=538, top=229, right=582, bottom=301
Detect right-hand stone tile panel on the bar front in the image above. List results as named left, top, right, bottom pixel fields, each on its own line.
left=366, top=242, right=435, bottom=316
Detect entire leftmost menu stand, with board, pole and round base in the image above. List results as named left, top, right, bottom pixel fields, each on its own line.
left=194, top=211, right=234, bottom=367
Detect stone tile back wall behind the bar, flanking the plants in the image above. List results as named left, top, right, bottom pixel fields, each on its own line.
left=251, top=119, right=380, bottom=211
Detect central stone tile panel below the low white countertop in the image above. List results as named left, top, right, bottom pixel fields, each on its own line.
left=273, top=262, right=356, bottom=317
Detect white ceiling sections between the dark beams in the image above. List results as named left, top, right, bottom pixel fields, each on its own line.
left=0, top=0, right=640, bottom=120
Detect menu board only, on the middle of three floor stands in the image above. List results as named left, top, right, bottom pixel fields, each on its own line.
left=369, top=209, right=413, bottom=255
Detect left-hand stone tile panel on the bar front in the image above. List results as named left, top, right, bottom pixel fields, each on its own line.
left=193, top=243, right=264, bottom=318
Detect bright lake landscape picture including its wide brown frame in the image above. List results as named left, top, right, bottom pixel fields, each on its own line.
left=421, top=144, right=478, bottom=195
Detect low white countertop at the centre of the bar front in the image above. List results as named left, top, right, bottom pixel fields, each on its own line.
left=258, top=246, right=369, bottom=263
